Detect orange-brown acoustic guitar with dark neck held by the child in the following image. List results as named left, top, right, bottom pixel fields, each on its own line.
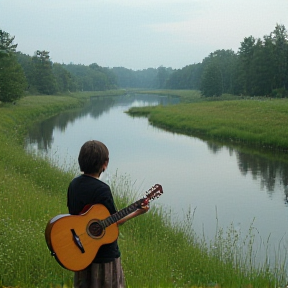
left=45, top=184, right=163, bottom=271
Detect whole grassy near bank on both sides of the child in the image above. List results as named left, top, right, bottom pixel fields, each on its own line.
left=0, top=92, right=287, bottom=288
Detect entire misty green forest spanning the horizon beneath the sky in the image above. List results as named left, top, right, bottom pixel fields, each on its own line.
left=0, top=24, right=288, bottom=102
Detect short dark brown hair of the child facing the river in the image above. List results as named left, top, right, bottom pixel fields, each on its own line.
left=78, top=140, right=109, bottom=174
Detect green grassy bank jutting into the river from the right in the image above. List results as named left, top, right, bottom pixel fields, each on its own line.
left=128, top=98, right=288, bottom=151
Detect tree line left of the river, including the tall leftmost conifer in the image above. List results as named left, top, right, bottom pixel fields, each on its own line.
left=0, top=29, right=118, bottom=102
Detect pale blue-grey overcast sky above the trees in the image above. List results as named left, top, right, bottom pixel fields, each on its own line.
left=0, top=0, right=288, bottom=70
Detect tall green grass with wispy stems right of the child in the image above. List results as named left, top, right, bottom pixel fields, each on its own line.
left=111, top=176, right=286, bottom=288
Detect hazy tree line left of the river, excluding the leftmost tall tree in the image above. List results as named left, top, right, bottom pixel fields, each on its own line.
left=16, top=50, right=117, bottom=94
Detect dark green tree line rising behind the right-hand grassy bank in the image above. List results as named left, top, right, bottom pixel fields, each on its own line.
left=166, top=24, right=288, bottom=97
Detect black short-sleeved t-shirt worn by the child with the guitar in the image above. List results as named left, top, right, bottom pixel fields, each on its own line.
left=67, top=175, right=120, bottom=263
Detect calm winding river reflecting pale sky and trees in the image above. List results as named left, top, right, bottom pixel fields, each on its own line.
left=27, top=95, right=288, bottom=264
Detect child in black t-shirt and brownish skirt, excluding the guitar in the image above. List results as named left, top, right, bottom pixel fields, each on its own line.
left=67, top=140, right=149, bottom=288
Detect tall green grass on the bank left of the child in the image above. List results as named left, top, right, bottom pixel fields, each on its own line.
left=0, top=96, right=83, bottom=287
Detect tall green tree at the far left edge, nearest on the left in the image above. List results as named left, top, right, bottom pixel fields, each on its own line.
left=0, top=30, right=27, bottom=102
